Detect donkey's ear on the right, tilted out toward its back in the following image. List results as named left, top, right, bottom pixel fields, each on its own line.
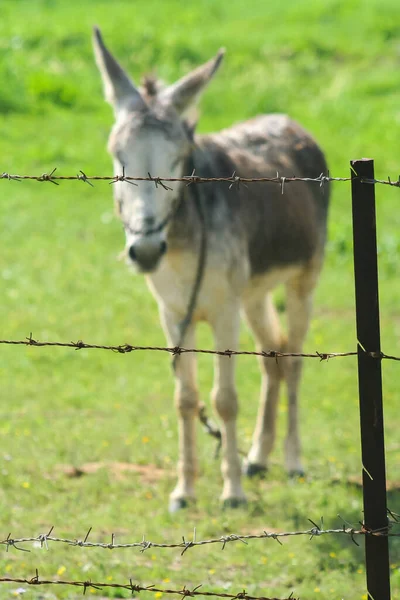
left=159, top=48, right=225, bottom=114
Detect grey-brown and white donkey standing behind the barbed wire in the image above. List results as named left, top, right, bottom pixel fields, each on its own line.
left=93, top=28, right=329, bottom=511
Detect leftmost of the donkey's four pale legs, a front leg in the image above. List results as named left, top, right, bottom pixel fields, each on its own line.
left=161, top=310, right=198, bottom=512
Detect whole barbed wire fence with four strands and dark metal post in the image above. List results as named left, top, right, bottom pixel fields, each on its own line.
left=0, top=159, right=400, bottom=600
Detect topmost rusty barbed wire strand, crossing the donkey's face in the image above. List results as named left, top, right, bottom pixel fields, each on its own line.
left=0, top=167, right=400, bottom=193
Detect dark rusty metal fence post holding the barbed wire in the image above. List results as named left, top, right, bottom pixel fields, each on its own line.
left=350, top=158, right=390, bottom=600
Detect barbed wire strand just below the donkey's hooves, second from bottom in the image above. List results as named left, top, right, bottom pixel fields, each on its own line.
left=0, top=509, right=400, bottom=555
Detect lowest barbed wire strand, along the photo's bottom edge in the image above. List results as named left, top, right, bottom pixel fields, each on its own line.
left=0, top=569, right=296, bottom=600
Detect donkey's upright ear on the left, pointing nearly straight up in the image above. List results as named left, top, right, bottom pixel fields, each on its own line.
left=93, top=27, right=145, bottom=114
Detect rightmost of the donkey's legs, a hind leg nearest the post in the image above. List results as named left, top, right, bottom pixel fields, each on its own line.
left=282, top=269, right=319, bottom=475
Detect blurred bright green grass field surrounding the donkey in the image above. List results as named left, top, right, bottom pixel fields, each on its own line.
left=0, top=0, right=400, bottom=600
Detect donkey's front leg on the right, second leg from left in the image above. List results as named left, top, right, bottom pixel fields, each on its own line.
left=212, top=302, right=246, bottom=507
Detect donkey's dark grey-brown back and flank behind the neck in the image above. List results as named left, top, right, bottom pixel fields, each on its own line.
left=195, top=114, right=330, bottom=275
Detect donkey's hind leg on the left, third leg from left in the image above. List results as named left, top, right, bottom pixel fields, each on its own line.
left=243, top=290, right=284, bottom=477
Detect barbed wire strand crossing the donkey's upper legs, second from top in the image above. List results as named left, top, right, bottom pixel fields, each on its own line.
left=0, top=333, right=400, bottom=361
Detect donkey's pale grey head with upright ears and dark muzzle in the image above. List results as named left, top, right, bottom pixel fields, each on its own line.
left=93, top=28, right=223, bottom=272
